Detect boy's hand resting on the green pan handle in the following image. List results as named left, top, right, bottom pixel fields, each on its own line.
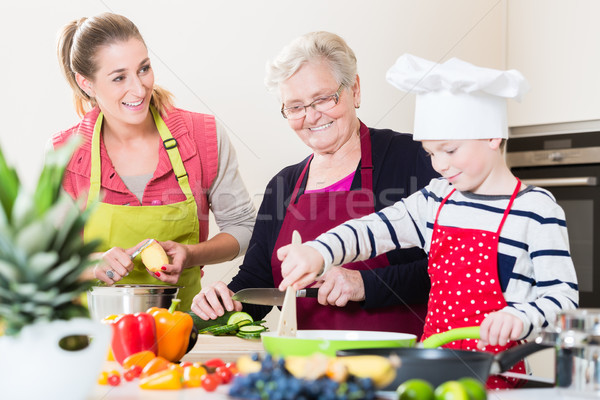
left=477, top=311, right=523, bottom=350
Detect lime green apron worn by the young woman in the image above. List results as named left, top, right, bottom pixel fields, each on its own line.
left=84, top=107, right=201, bottom=310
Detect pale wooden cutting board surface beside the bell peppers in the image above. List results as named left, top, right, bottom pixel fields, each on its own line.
left=182, top=335, right=265, bottom=362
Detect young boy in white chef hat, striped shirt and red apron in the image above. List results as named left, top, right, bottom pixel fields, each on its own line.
left=278, top=55, right=579, bottom=387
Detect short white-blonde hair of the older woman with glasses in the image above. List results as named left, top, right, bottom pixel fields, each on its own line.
left=265, top=31, right=357, bottom=91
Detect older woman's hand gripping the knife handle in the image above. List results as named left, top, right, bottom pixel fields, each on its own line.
left=313, top=267, right=365, bottom=307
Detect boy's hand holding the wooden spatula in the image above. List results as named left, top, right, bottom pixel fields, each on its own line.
left=277, top=244, right=323, bottom=290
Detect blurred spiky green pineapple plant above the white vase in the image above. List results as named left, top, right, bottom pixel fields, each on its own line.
left=0, top=141, right=98, bottom=335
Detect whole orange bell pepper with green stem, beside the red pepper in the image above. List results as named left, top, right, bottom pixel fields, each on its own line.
left=146, top=299, right=194, bottom=362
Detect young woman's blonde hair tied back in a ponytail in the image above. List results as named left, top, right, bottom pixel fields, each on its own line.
left=57, top=13, right=173, bottom=117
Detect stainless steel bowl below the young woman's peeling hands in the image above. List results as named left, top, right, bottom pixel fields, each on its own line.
left=87, top=285, right=180, bottom=321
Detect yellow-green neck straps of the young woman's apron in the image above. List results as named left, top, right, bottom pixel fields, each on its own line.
left=86, top=106, right=194, bottom=208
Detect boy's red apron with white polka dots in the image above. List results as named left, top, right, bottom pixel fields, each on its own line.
left=423, top=179, right=525, bottom=389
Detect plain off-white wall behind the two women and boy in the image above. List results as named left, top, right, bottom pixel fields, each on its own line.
left=0, top=0, right=506, bottom=318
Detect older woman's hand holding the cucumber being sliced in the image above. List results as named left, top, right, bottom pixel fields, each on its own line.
left=192, top=281, right=242, bottom=320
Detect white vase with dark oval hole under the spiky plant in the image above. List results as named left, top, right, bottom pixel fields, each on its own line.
left=0, top=318, right=112, bottom=400
